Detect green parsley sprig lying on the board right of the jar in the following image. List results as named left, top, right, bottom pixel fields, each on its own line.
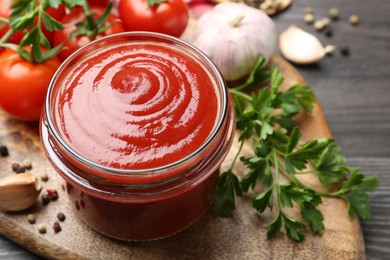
left=214, top=56, right=378, bottom=241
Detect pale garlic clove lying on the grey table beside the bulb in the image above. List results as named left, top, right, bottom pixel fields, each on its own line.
left=279, top=25, right=325, bottom=64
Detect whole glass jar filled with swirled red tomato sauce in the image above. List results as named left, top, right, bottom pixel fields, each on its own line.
left=41, top=32, right=234, bottom=240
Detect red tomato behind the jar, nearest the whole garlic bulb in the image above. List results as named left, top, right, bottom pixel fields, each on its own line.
left=118, top=0, right=188, bottom=37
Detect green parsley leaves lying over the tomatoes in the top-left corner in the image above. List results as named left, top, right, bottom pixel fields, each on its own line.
left=0, top=0, right=112, bottom=63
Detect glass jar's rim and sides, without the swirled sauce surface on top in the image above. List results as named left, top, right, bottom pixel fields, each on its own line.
left=40, top=32, right=235, bottom=241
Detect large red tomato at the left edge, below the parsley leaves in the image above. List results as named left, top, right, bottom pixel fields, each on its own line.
left=0, top=49, right=61, bottom=121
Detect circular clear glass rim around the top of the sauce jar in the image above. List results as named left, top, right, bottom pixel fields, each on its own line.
left=44, top=31, right=228, bottom=177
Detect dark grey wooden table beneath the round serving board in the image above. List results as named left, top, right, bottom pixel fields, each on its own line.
left=0, top=0, right=390, bottom=259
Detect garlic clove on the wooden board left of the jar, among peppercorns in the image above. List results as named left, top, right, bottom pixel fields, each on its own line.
left=0, top=173, right=41, bottom=211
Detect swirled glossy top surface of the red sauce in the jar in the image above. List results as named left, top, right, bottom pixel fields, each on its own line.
left=54, top=42, right=221, bottom=169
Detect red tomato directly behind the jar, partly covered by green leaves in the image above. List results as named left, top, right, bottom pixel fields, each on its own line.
left=53, top=6, right=124, bottom=60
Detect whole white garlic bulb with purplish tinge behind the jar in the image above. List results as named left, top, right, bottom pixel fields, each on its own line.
left=194, top=2, right=276, bottom=81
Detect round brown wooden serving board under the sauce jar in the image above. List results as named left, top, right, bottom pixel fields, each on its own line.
left=0, top=56, right=365, bottom=259
